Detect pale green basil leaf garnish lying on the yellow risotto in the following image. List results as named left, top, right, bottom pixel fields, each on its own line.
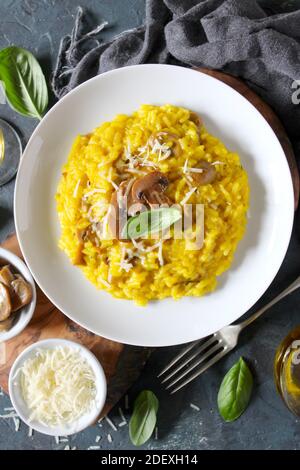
left=122, top=207, right=181, bottom=238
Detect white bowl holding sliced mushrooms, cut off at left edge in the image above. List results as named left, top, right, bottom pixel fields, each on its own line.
left=0, top=248, right=36, bottom=343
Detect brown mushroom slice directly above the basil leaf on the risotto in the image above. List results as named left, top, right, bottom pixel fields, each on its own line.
left=131, top=171, right=170, bottom=207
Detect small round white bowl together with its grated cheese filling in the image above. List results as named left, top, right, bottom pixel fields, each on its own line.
left=10, top=340, right=106, bottom=435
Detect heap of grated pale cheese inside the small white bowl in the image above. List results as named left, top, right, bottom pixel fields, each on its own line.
left=17, top=346, right=96, bottom=427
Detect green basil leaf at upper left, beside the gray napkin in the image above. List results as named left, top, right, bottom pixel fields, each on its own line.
left=0, top=46, right=48, bottom=119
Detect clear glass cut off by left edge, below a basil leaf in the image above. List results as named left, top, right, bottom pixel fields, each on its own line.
left=0, top=119, right=22, bottom=186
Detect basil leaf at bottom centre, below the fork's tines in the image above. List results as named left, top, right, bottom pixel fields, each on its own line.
left=129, top=390, right=159, bottom=446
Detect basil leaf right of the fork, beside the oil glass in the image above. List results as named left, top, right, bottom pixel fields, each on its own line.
left=218, top=357, right=253, bottom=422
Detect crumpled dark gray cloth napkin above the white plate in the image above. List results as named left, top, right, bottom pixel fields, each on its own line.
left=52, top=0, right=300, bottom=147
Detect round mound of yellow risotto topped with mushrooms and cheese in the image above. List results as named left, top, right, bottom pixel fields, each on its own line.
left=56, top=104, right=249, bottom=305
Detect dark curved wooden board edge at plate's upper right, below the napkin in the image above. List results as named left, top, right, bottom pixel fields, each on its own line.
left=196, top=68, right=300, bottom=210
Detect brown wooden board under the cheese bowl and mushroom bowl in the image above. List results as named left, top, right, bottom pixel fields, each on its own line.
left=0, top=235, right=151, bottom=415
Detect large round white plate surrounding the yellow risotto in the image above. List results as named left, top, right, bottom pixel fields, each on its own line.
left=15, top=65, right=293, bottom=346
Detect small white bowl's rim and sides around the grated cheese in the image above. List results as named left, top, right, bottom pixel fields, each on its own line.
left=8, top=338, right=106, bottom=436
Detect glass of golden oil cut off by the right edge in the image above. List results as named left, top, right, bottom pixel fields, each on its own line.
left=274, top=326, right=300, bottom=416
